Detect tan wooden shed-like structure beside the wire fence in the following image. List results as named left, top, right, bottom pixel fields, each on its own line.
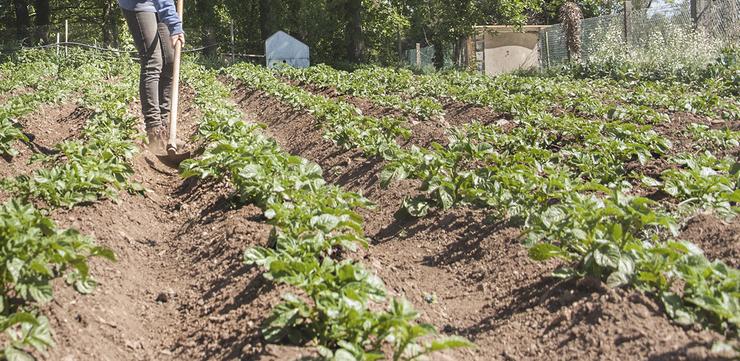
left=467, top=25, right=548, bottom=75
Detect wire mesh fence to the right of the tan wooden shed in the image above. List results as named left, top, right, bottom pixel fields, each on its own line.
left=540, top=0, right=740, bottom=67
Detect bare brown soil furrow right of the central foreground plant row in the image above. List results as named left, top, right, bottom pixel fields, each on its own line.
left=230, top=81, right=721, bottom=360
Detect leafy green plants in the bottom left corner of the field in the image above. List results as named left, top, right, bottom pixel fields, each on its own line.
left=0, top=200, right=115, bottom=360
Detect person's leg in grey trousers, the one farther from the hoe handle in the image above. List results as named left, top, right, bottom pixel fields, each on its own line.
left=123, top=10, right=162, bottom=130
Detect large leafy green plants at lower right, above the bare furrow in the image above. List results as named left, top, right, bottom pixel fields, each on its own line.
left=528, top=189, right=740, bottom=335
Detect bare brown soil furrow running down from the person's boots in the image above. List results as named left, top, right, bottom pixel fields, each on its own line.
left=31, top=90, right=314, bottom=360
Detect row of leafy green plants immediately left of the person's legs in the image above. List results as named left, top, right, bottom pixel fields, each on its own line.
left=2, top=52, right=143, bottom=208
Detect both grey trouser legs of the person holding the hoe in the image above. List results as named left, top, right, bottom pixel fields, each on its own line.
left=123, top=10, right=174, bottom=129
